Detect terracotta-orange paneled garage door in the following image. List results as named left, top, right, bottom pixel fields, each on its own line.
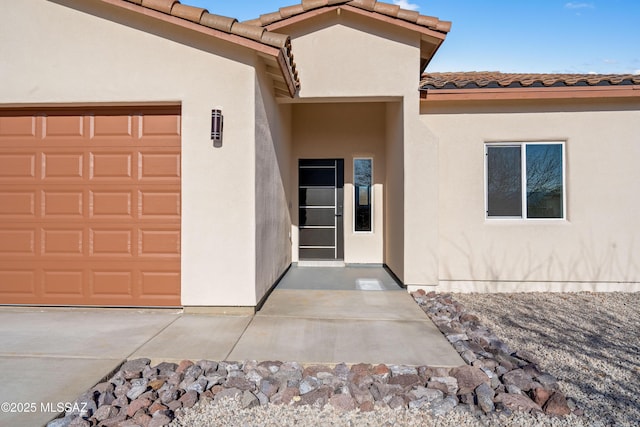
left=0, top=108, right=181, bottom=306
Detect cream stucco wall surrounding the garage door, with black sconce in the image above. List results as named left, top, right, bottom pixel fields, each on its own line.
left=0, top=0, right=256, bottom=305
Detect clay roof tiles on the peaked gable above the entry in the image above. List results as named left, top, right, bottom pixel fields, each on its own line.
left=245, top=0, right=451, bottom=33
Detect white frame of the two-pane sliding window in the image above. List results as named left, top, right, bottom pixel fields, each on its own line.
left=483, top=140, right=567, bottom=221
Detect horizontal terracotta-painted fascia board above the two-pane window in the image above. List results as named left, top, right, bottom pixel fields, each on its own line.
left=420, top=86, right=640, bottom=102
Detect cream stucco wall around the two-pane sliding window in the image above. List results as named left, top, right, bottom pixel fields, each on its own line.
left=422, top=101, right=640, bottom=291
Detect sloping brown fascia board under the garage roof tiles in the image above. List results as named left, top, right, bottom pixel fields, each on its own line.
left=97, top=0, right=280, bottom=58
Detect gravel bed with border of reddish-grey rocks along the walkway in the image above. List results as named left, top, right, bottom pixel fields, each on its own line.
left=49, top=291, right=640, bottom=427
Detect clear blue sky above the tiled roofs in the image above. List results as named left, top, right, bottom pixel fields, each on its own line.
left=182, top=0, right=640, bottom=74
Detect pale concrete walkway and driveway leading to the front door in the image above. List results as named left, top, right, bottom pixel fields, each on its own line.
left=0, top=269, right=464, bottom=426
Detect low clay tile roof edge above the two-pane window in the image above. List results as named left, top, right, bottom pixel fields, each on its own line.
left=420, top=71, right=640, bottom=90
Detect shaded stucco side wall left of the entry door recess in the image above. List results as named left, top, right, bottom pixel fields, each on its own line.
left=255, top=67, right=291, bottom=303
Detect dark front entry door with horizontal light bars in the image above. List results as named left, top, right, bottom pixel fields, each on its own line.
left=298, top=159, right=344, bottom=260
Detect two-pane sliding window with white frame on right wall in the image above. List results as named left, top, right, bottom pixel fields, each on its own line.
left=486, top=142, right=565, bottom=219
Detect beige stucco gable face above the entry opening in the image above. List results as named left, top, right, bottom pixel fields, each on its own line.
left=286, top=10, right=420, bottom=98
